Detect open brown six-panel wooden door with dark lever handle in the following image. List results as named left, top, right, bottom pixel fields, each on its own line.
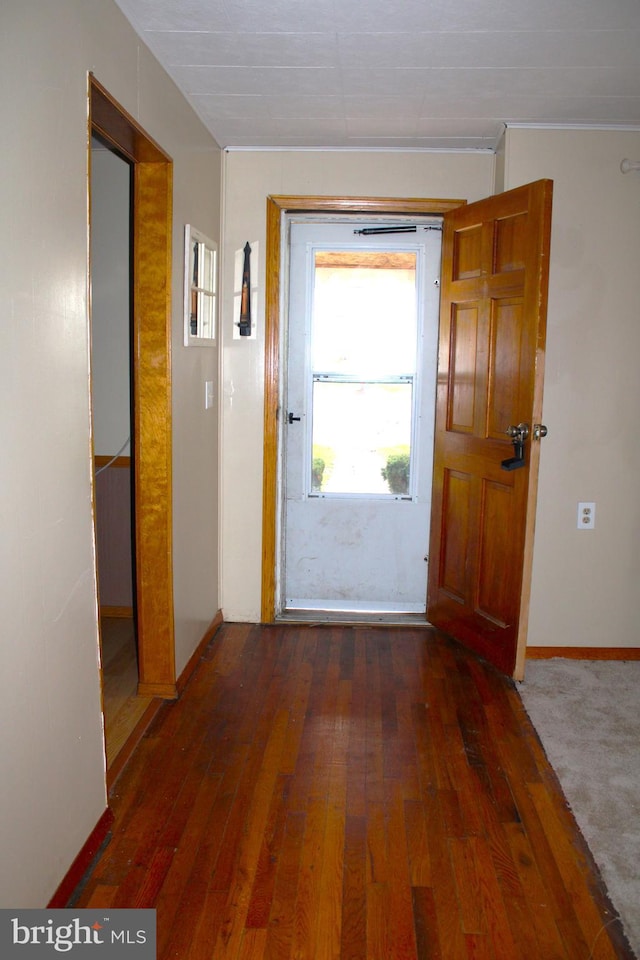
left=427, top=180, right=553, bottom=677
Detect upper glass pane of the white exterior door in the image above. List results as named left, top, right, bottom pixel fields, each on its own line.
left=311, top=250, right=417, bottom=378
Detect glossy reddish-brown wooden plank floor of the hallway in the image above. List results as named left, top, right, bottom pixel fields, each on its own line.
left=75, top=624, right=633, bottom=960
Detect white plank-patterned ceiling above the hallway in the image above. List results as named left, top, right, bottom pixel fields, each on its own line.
left=116, top=0, right=640, bottom=150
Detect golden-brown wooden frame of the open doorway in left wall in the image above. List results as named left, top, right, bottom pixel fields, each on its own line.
left=88, top=74, right=177, bottom=699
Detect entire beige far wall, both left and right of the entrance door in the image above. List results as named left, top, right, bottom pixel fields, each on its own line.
left=222, top=128, right=640, bottom=646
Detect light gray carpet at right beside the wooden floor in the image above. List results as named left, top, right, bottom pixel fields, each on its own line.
left=518, top=659, right=640, bottom=957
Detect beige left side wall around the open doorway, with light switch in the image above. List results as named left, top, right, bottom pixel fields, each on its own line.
left=0, top=0, right=220, bottom=907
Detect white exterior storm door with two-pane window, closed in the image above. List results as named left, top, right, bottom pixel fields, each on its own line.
left=278, top=216, right=441, bottom=615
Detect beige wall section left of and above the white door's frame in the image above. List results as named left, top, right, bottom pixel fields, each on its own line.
left=222, top=151, right=494, bottom=621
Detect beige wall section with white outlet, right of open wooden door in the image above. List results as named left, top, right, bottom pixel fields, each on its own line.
left=505, top=128, right=640, bottom=646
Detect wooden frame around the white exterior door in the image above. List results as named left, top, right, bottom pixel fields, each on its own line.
left=261, top=195, right=467, bottom=623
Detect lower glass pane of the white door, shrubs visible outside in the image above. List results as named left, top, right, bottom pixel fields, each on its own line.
left=311, top=380, right=412, bottom=496
